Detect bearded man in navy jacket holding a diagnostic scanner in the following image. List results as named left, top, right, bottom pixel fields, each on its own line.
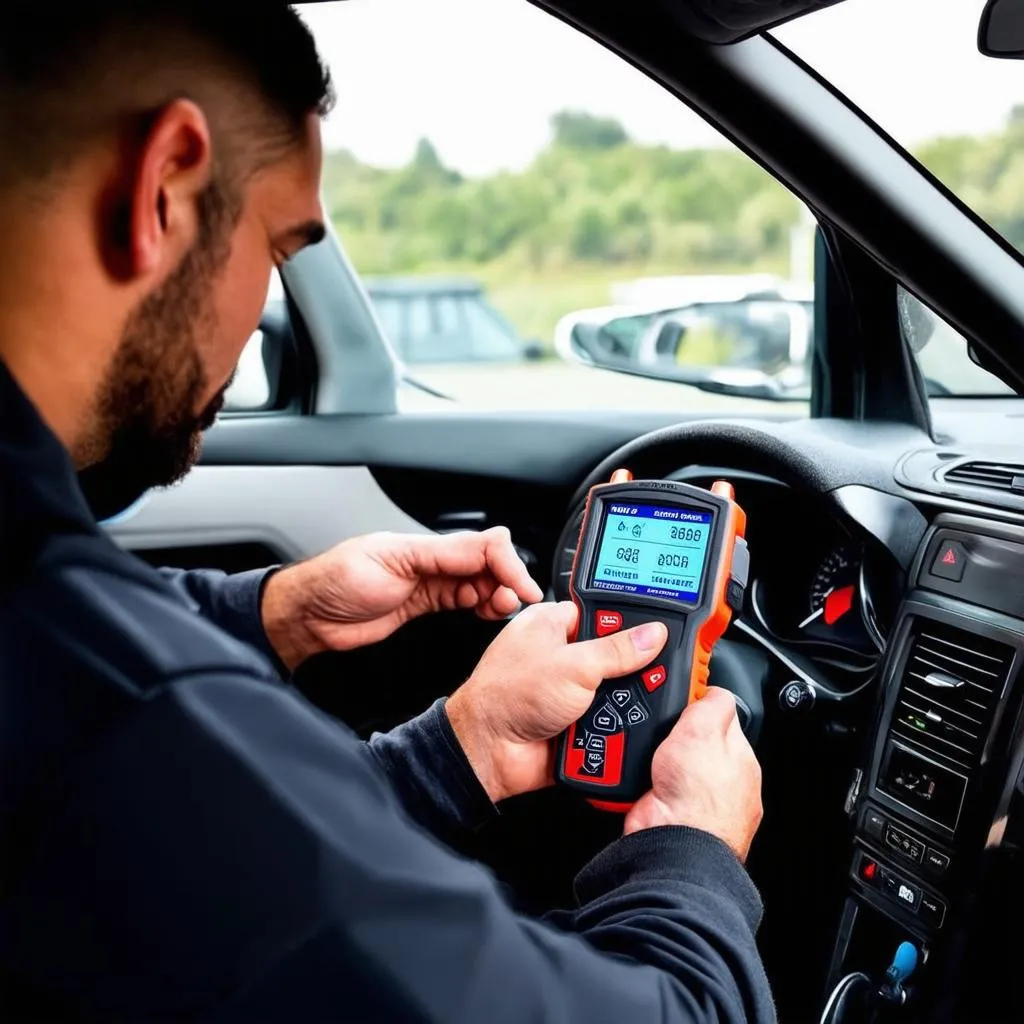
left=0, top=0, right=773, bottom=1024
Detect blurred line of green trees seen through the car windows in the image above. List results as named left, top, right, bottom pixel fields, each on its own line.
left=324, top=105, right=1024, bottom=280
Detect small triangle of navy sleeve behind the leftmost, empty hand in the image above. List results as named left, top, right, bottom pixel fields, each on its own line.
left=158, top=565, right=289, bottom=679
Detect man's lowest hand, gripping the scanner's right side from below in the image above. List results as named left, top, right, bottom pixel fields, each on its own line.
left=626, top=686, right=763, bottom=861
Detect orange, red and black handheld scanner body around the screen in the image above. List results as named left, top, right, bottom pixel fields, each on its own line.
left=555, top=469, right=749, bottom=813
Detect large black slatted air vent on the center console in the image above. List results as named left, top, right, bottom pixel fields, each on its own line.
left=892, top=620, right=1014, bottom=768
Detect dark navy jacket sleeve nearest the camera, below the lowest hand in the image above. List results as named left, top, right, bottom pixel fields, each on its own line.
left=0, top=672, right=774, bottom=1024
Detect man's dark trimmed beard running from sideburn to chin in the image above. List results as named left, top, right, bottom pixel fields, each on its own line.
left=80, top=180, right=236, bottom=518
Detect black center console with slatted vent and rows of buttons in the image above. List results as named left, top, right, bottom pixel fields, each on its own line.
left=827, top=515, right=1024, bottom=1024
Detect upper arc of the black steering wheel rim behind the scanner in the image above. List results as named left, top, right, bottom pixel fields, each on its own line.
left=569, top=420, right=833, bottom=514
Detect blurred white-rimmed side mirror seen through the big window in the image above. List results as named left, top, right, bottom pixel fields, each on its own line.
left=556, top=297, right=813, bottom=391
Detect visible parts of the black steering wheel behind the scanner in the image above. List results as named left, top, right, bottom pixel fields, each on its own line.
left=555, top=421, right=848, bottom=742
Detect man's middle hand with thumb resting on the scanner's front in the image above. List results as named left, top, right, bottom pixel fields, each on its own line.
left=445, top=602, right=667, bottom=803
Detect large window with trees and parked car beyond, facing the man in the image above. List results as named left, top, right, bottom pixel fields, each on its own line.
left=303, top=0, right=814, bottom=415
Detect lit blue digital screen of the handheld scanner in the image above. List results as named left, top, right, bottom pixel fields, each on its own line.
left=592, top=504, right=713, bottom=601
